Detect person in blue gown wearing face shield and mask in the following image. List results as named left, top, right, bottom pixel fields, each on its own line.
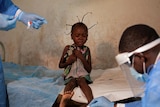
left=88, top=24, right=160, bottom=107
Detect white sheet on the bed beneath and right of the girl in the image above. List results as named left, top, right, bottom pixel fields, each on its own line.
left=61, top=67, right=133, bottom=103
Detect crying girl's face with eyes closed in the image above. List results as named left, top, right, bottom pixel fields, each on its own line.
left=71, top=27, right=88, bottom=47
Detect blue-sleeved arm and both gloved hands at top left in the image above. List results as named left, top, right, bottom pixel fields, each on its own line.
left=0, top=0, right=47, bottom=31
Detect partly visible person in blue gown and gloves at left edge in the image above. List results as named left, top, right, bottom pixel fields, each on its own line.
left=0, top=0, right=47, bottom=107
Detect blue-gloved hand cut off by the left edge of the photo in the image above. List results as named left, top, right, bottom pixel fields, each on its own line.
left=0, top=14, right=17, bottom=31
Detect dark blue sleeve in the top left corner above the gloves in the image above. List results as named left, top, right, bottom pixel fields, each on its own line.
left=0, top=0, right=19, bottom=16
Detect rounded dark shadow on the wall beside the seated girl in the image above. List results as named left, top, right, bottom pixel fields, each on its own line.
left=92, top=42, right=117, bottom=69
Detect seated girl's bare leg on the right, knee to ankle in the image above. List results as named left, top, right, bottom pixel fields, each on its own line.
left=77, top=77, right=93, bottom=103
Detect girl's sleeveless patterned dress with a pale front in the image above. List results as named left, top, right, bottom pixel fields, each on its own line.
left=64, top=44, right=92, bottom=84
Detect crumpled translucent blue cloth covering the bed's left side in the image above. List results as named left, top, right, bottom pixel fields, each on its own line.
left=3, top=62, right=64, bottom=107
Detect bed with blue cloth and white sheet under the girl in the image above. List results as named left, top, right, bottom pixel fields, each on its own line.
left=3, top=62, right=140, bottom=107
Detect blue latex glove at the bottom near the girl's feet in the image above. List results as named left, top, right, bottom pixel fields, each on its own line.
left=88, top=96, right=114, bottom=107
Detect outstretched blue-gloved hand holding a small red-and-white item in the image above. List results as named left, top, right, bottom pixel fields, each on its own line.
left=18, top=12, right=47, bottom=29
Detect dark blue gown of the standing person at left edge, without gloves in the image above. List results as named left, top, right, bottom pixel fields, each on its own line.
left=0, top=0, right=19, bottom=107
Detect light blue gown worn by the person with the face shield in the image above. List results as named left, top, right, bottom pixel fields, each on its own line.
left=125, top=60, right=160, bottom=107
